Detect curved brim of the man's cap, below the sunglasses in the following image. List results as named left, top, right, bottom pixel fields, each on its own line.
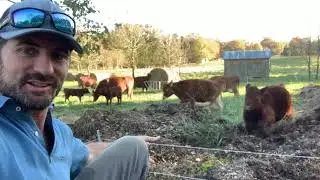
left=0, top=28, right=83, bottom=54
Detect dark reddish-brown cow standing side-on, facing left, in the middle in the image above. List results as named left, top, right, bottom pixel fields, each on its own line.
left=162, top=79, right=225, bottom=109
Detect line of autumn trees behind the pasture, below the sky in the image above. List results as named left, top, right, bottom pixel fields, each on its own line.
left=57, top=0, right=319, bottom=74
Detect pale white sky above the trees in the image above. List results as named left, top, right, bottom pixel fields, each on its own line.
left=0, top=0, right=320, bottom=42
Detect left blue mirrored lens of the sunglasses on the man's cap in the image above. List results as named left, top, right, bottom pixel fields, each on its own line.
left=13, top=9, right=45, bottom=28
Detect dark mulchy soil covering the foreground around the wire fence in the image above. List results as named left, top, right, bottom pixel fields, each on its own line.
left=72, top=86, right=320, bottom=180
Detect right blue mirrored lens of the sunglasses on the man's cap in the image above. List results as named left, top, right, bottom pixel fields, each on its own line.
left=52, top=13, right=75, bottom=35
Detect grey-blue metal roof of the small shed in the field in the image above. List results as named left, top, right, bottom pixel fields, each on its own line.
left=223, top=50, right=272, bottom=60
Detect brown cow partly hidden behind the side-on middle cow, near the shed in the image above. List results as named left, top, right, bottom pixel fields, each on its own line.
left=210, top=76, right=240, bottom=96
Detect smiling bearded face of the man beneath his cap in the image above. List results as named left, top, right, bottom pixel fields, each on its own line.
left=0, top=34, right=70, bottom=110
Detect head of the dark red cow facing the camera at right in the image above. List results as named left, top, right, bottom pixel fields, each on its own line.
left=244, top=84, right=262, bottom=111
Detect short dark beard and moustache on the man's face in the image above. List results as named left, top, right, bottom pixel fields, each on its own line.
left=0, top=61, right=63, bottom=110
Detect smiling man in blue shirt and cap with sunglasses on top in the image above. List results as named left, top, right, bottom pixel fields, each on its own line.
left=0, top=0, right=159, bottom=180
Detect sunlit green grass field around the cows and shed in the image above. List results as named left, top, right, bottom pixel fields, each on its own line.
left=54, top=56, right=316, bottom=123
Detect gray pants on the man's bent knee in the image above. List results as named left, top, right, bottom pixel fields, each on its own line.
left=76, top=136, right=149, bottom=180
